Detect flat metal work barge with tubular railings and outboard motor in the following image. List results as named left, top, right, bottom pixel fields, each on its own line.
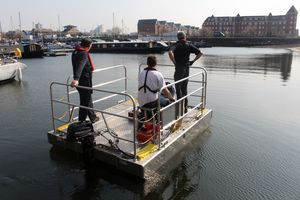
left=47, top=64, right=212, bottom=179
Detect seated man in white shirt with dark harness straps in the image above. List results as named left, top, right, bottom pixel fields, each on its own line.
left=138, top=55, right=175, bottom=108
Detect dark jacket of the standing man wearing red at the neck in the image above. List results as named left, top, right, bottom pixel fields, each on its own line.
left=72, top=50, right=93, bottom=87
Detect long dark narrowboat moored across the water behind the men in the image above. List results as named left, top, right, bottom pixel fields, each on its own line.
left=90, top=41, right=168, bottom=53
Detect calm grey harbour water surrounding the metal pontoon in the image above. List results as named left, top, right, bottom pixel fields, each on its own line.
left=0, top=48, right=300, bottom=200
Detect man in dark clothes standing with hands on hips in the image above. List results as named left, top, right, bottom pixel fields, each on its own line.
left=169, top=31, right=202, bottom=129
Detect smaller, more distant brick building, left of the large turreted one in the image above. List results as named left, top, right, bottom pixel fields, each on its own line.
left=137, top=19, right=199, bottom=36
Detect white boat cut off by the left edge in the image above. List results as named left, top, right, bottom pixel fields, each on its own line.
left=0, top=57, right=26, bottom=81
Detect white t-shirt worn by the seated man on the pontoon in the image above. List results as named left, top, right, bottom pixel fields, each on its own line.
left=138, top=70, right=166, bottom=106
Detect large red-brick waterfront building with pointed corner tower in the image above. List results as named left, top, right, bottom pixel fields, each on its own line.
left=202, top=6, right=298, bottom=37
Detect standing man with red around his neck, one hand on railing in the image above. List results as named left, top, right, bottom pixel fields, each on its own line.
left=71, top=38, right=99, bottom=123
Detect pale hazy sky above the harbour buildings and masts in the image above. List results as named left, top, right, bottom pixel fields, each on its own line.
left=0, top=0, right=300, bottom=33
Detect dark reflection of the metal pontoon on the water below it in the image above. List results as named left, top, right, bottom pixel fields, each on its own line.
left=49, top=127, right=211, bottom=200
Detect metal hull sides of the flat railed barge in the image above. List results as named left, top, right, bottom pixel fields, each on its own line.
left=48, top=109, right=212, bottom=179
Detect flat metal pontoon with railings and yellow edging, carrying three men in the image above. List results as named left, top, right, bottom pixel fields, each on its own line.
left=48, top=65, right=212, bottom=178
